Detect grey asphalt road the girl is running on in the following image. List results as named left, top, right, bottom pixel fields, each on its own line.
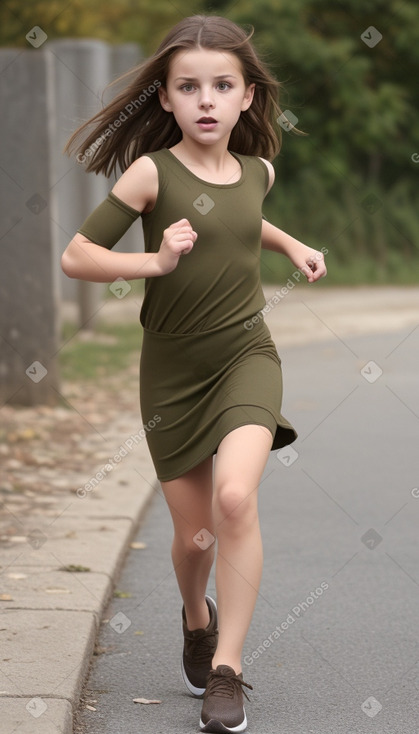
left=76, top=328, right=419, bottom=734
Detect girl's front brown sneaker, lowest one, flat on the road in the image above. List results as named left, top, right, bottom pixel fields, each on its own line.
left=199, top=665, right=253, bottom=734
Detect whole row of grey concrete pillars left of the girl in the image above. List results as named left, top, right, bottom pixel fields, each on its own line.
left=0, top=39, right=143, bottom=405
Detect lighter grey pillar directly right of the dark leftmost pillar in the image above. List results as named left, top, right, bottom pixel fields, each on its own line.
left=45, top=39, right=111, bottom=329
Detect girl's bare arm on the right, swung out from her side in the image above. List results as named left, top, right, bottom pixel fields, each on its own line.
left=261, top=158, right=327, bottom=283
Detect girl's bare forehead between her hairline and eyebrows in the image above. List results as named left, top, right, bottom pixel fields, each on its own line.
left=169, top=48, right=243, bottom=78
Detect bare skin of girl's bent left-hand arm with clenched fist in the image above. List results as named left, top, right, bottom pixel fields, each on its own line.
left=61, top=157, right=198, bottom=283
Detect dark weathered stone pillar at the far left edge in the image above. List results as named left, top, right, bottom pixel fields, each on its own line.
left=0, top=49, right=58, bottom=405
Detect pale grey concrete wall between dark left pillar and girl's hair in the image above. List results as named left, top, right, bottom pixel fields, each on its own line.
left=45, top=39, right=143, bottom=301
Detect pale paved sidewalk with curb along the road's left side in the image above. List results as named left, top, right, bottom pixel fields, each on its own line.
left=0, top=434, right=157, bottom=734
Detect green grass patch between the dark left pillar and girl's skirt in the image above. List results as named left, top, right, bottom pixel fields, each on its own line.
left=60, top=323, right=142, bottom=382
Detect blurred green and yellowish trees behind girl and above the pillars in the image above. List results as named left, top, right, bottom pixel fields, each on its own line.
left=0, top=0, right=419, bottom=285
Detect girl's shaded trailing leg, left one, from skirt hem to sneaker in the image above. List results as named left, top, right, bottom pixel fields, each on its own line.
left=161, top=456, right=215, bottom=630
